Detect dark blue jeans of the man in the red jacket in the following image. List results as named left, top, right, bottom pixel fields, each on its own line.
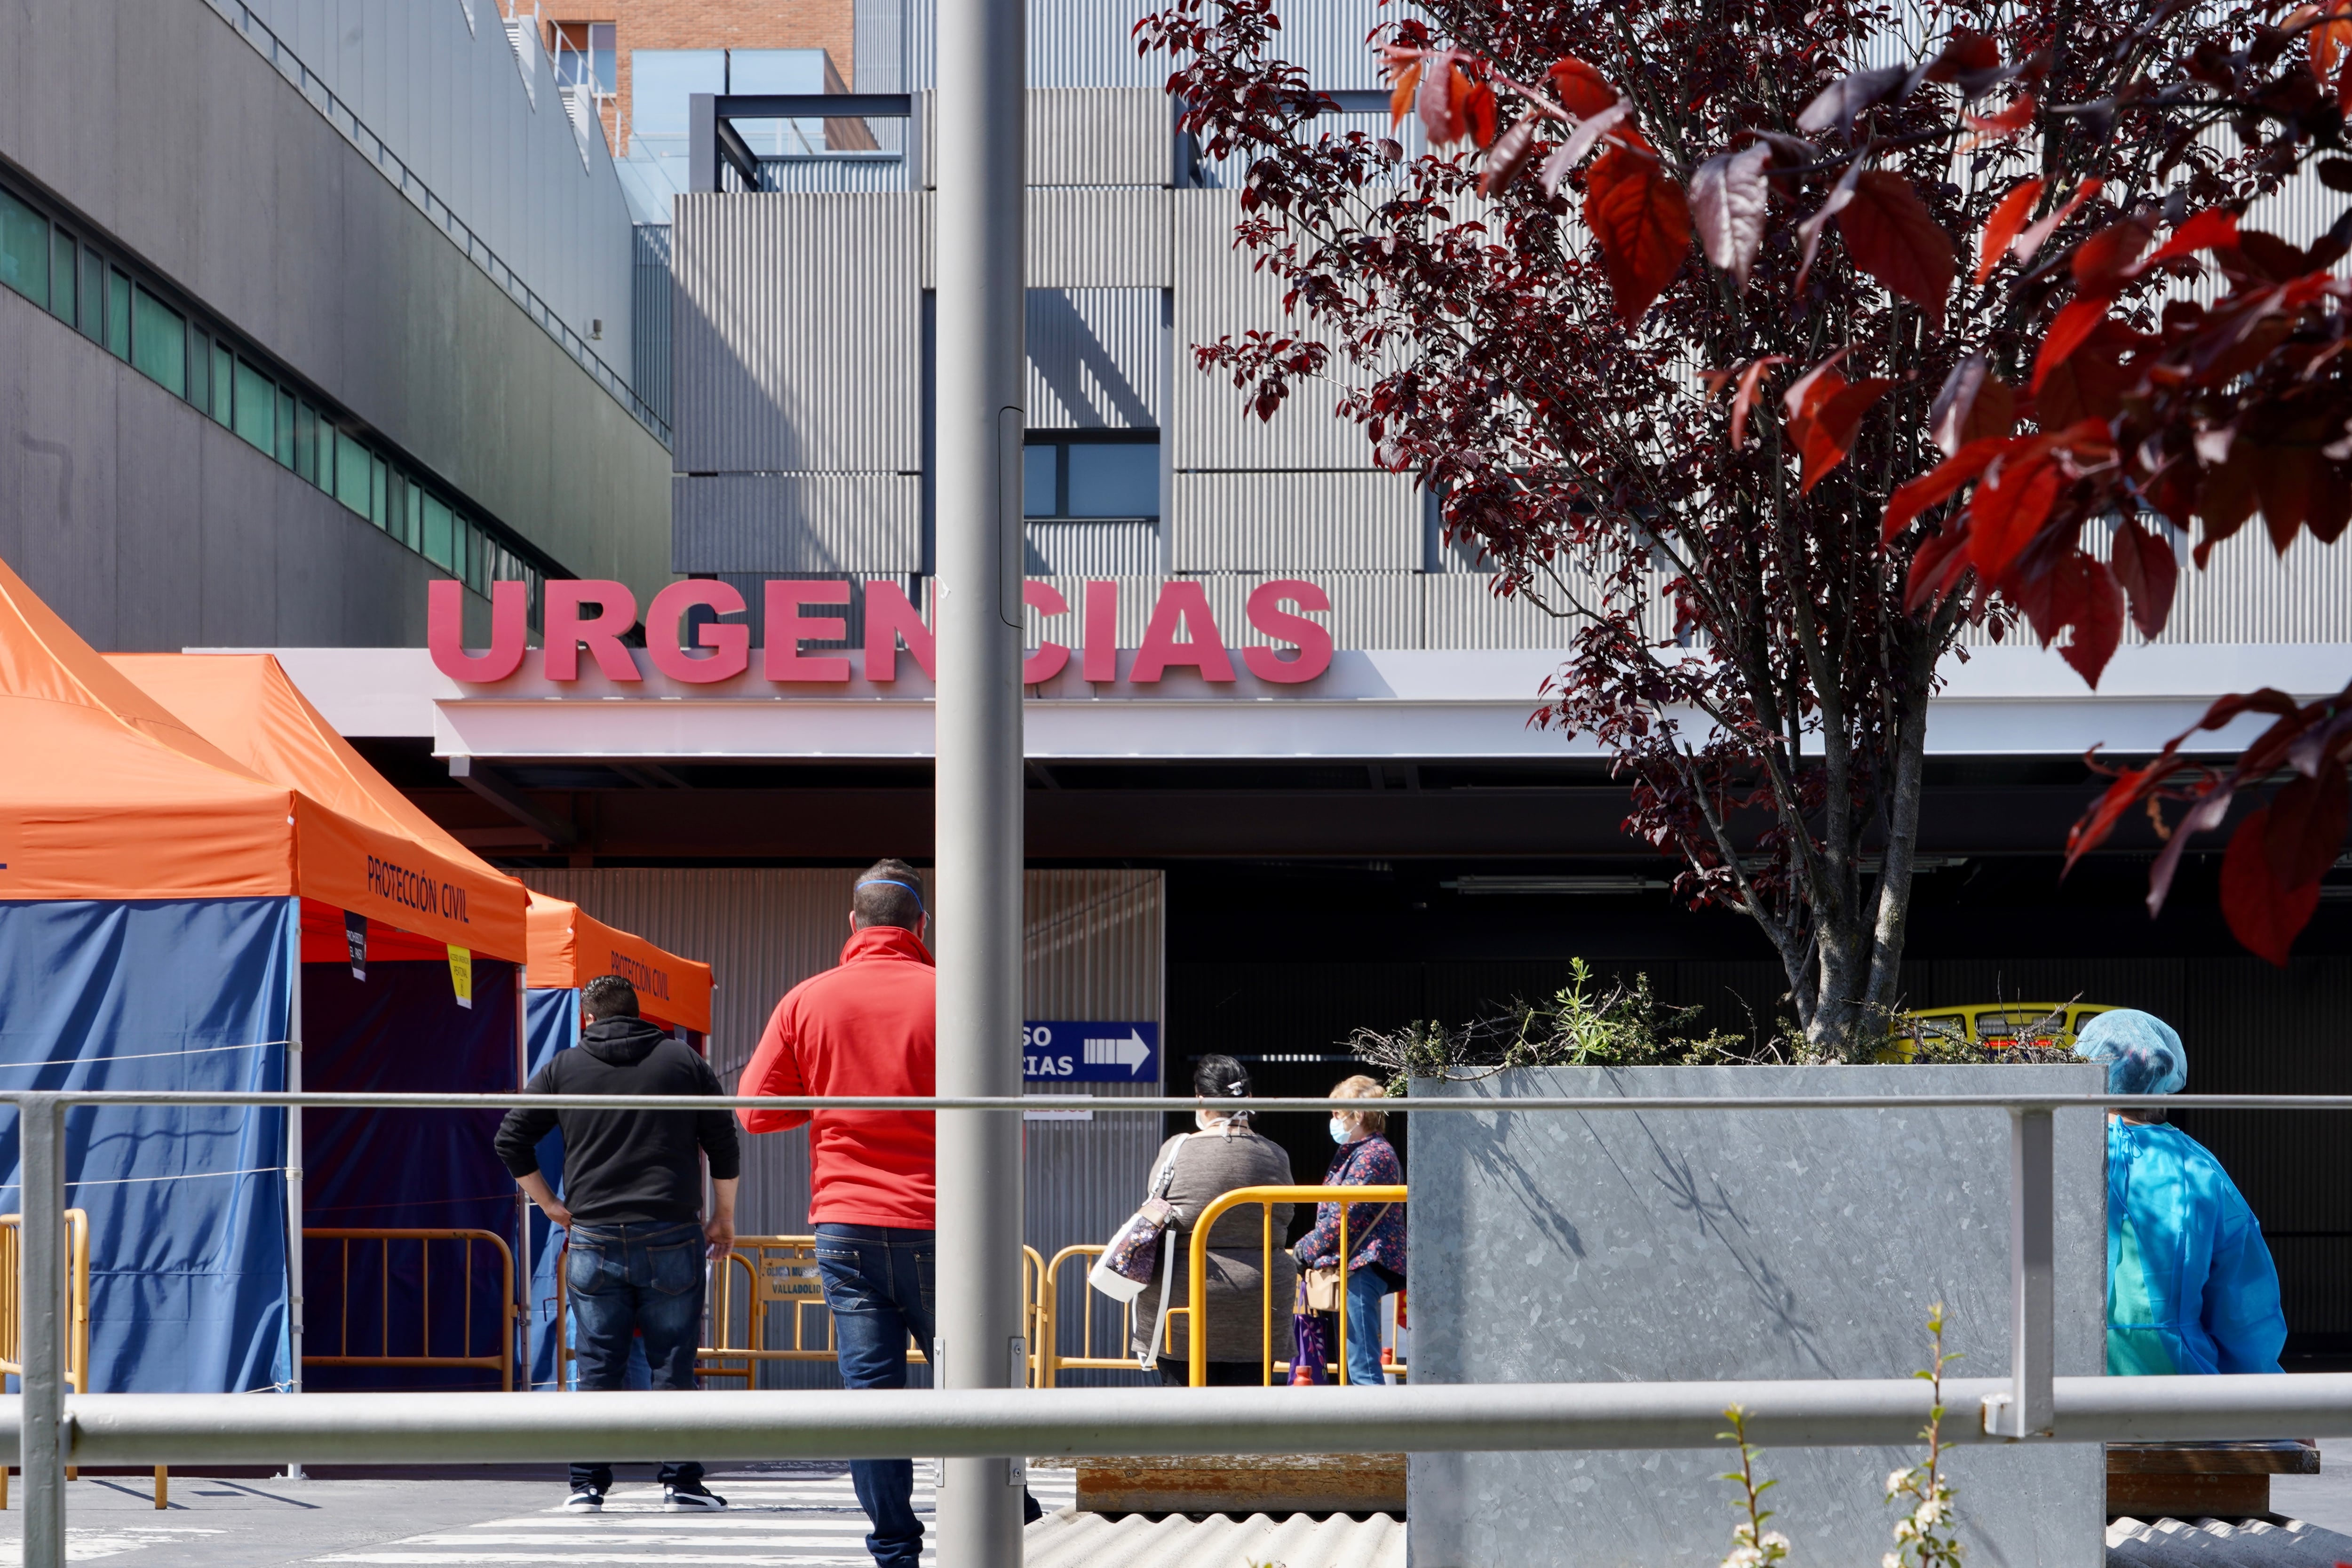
left=816, top=1225, right=938, bottom=1568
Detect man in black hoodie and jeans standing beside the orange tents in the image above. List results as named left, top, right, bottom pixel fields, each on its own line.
left=499, top=976, right=743, bottom=1514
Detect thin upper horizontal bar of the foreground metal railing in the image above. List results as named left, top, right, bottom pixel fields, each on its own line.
left=0, top=1089, right=2352, bottom=1117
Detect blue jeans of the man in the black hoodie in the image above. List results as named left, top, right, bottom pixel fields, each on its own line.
left=564, top=1220, right=703, bottom=1488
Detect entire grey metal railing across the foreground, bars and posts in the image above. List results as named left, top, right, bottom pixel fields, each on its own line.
left=0, top=1091, right=2352, bottom=1568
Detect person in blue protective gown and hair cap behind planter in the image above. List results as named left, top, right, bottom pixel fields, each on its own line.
left=2074, top=1009, right=2286, bottom=1377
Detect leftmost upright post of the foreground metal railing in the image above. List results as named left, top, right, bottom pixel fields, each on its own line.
left=16, top=1093, right=66, bottom=1568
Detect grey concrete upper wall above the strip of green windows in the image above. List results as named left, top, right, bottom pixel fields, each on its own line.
left=0, top=0, right=670, bottom=611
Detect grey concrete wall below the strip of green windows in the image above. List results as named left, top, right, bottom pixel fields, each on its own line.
left=0, top=289, right=489, bottom=651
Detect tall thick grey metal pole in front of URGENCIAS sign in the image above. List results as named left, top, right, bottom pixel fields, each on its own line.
left=931, top=0, right=1028, bottom=1542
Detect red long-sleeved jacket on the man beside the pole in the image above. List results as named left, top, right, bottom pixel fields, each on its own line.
left=736, top=926, right=938, bottom=1229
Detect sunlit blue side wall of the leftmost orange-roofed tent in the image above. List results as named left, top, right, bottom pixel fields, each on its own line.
left=0, top=898, right=296, bottom=1394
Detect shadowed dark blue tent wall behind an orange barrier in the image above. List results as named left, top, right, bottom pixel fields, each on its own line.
left=303, top=957, right=527, bottom=1389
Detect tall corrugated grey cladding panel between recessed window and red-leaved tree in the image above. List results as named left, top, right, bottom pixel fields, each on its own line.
left=1169, top=191, right=1371, bottom=470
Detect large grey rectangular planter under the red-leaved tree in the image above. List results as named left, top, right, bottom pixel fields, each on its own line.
left=1411, top=1065, right=2107, bottom=1568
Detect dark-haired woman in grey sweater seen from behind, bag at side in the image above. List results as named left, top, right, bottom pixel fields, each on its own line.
left=1136, top=1056, right=1298, bottom=1387
